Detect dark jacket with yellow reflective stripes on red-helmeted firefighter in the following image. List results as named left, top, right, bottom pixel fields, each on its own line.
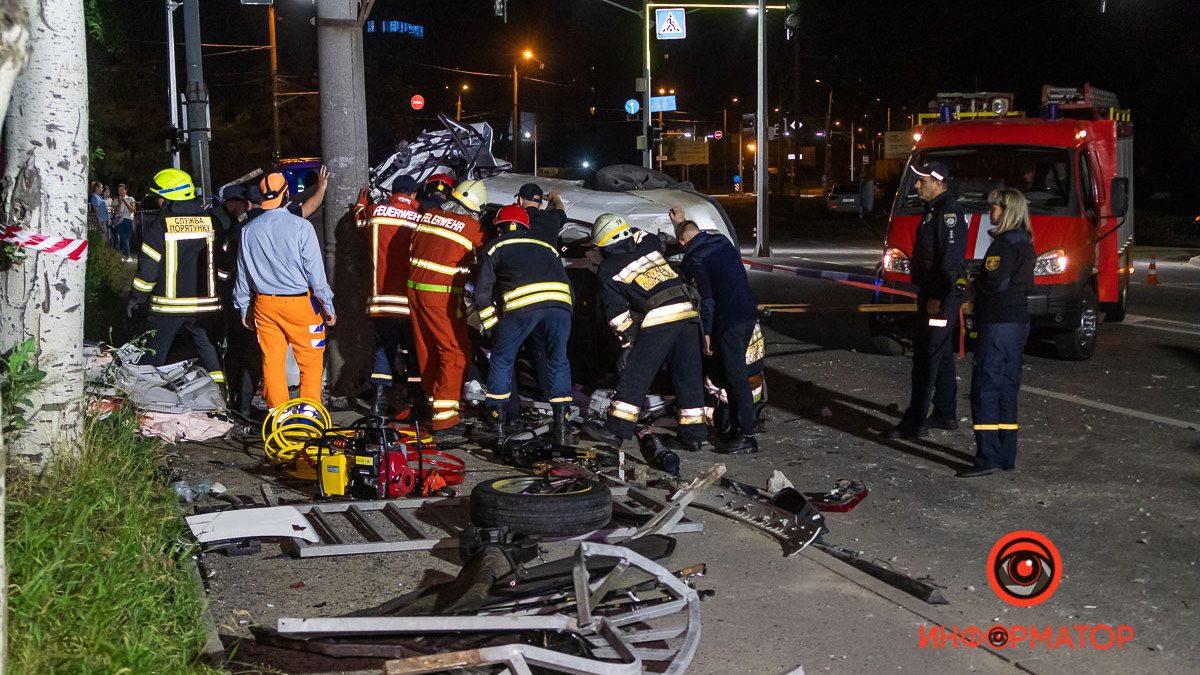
left=474, top=228, right=571, bottom=330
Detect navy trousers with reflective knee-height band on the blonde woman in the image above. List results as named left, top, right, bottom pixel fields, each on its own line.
left=971, top=323, right=1030, bottom=470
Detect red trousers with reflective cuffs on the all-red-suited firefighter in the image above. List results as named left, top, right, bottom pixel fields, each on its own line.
left=408, top=291, right=470, bottom=431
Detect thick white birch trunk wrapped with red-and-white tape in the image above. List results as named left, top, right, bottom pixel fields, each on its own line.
left=0, top=0, right=89, bottom=466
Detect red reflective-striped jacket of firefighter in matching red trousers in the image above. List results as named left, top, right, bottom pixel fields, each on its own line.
left=408, top=209, right=484, bottom=294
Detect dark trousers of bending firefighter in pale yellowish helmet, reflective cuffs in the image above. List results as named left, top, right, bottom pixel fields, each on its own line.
left=605, top=319, right=708, bottom=441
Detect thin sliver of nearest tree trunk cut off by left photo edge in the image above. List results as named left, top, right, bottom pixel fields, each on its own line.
left=0, top=0, right=29, bottom=673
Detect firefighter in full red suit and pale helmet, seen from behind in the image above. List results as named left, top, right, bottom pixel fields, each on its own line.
left=408, top=180, right=487, bottom=435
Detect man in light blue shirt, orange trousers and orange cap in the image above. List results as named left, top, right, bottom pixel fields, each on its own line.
left=233, top=173, right=337, bottom=410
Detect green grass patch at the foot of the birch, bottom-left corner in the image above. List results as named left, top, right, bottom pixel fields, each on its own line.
left=7, top=410, right=216, bottom=674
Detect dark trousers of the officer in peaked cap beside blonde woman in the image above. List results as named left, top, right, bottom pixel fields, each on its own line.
left=900, top=298, right=959, bottom=431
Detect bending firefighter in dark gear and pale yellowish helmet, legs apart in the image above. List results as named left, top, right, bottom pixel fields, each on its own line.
left=583, top=214, right=708, bottom=450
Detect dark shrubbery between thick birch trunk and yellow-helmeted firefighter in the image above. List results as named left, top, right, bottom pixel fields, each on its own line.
left=83, top=231, right=137, bottom=345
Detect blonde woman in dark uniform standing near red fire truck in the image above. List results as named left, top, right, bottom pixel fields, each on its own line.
left=959, top=189, right=1036, bottom=478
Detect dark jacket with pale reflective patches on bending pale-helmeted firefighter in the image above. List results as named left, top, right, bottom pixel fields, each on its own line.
left=596, top=229, right=700, bottom=339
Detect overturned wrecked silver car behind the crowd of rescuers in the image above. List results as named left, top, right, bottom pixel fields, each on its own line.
left=370, top=115, right=738, bottom=389
